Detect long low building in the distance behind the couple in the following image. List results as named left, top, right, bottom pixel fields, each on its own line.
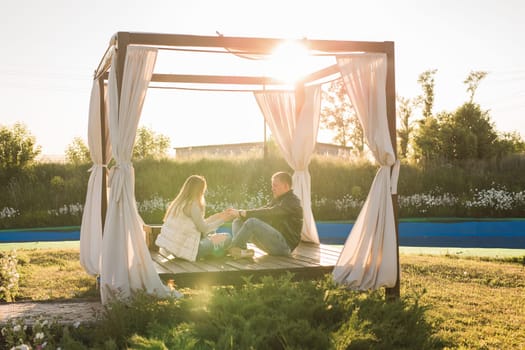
left=174, top=142, right=351, bottom=159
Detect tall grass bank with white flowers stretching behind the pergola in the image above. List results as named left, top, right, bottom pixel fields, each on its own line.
left=0, top=155, right=525, bottom=229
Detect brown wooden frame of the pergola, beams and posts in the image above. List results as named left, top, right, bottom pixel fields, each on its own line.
left=95, top=32, right=399, bottom=298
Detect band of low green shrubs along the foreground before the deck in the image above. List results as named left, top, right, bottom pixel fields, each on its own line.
left=0, top=274, right=440, bottom=350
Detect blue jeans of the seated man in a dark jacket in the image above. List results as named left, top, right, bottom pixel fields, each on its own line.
left=232, top=218, right=290, bottom=255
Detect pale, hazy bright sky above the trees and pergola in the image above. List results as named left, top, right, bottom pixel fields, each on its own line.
left=0, top=0, right=525, bottom=155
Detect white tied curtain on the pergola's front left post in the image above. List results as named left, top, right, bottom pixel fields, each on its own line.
left=100, top=47, right=172, bottom=303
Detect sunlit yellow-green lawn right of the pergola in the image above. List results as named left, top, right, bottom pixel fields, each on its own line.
left=401, top=255, right=525, bottom=349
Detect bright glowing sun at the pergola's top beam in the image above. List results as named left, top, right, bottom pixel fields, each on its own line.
left=267, top=40, right=310, bottom=85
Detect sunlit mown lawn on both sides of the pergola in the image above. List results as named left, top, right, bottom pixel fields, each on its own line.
left=2, top=246, right=525, bottom=349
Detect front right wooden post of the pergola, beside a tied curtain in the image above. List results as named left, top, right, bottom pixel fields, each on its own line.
left=385, top=42, right=401, bottom=300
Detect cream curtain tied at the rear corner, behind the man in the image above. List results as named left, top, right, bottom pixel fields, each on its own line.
left=255, top=85, right=321, bottom=244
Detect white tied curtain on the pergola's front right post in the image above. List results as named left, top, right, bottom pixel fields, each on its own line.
left=333, top=54, right=397, bottom=290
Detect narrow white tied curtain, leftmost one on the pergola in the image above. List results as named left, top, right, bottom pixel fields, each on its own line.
left=80, top=79, right=111, bottom=275
